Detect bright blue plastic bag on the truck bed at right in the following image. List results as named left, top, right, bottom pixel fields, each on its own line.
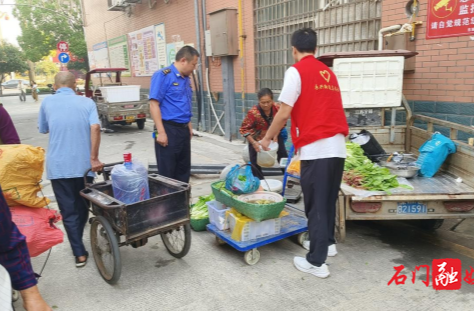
left=416, top=132, right=456, bottom=178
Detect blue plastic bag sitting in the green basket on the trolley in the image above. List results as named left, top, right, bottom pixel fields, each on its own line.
left=225, top=165, right=260, bottom=195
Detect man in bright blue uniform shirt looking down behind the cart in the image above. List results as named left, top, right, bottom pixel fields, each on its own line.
left=150, top=46, right=199, bottom=183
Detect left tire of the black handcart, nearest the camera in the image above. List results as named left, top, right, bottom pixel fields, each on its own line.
left=90, top=216, right=122, bottom=285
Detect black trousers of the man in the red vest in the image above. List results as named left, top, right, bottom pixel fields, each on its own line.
left=301, top=158, right=345, bottom=266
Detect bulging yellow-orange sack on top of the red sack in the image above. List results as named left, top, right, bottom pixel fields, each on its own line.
left=0, top=144, right=50, bottom=208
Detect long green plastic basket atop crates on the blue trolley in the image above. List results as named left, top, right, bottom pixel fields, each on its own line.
left=211, top=181, right=286, bottom=222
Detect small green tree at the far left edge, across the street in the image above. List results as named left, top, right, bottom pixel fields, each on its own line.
left=0, top=41, right=28, bottom=95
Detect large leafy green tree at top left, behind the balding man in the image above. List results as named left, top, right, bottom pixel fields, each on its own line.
left=13, top=0, right=89, bottom=80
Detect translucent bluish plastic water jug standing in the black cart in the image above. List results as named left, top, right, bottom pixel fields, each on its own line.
left=111, top=159, right=150, bottom=204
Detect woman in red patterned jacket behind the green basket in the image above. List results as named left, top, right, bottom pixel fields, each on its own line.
left=240, top=88, right=288, bottom=179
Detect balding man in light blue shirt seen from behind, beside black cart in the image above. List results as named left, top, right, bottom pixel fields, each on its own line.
left=38, top=72, right=102, bottom=267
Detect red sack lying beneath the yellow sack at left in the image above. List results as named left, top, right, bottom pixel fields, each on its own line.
left=10, top=206, right=64, bottom=257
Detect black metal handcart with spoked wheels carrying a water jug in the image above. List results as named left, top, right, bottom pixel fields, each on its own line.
left=81, top=165, right=191, bottom=284
